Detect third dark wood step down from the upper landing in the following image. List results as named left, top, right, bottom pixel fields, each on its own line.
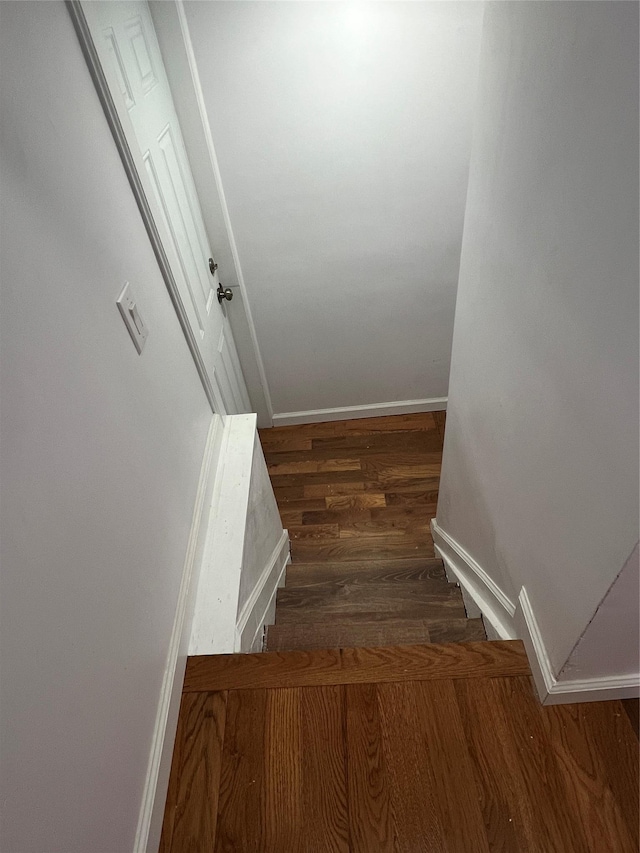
left=286, top=559, right=447, bottom=587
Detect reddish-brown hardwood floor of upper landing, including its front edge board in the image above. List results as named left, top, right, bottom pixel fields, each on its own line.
left=161, top=642, right=638, bottom=853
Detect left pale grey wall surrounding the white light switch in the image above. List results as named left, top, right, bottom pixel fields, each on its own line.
left=0, top=2, right=211, bottom=853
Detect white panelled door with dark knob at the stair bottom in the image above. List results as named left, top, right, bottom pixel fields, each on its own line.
left=83, top=0, right=251, bottom=415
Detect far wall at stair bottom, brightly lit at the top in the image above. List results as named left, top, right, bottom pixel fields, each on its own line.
left=185, top=2, right=482, bottom=420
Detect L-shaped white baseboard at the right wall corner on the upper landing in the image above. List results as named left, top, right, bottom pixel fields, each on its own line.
left=516, top=587, right=640, bottom=705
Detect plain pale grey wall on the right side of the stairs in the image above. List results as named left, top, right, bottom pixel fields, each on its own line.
left=437, top=2, right=638, bottom=673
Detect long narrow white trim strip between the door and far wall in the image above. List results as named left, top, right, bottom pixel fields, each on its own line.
left=175, top=0, right=273, bottom=417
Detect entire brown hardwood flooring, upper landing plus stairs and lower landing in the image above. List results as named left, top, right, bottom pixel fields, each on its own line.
left=161, top=413, right=639, bottom=853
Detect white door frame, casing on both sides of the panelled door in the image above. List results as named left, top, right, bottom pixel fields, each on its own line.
left=66, top=0, right=273, bottom=426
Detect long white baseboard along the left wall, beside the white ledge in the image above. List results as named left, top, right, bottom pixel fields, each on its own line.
left=133, top=415, right=223, bottom=853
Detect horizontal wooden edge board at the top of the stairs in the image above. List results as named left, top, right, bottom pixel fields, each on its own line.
left=183, top=640, right=531, bottom=693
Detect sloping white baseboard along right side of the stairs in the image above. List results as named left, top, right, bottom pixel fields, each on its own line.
left=431, top=518, right=519, bottom=640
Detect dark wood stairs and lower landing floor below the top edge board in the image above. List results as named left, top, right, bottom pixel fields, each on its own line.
left=260, top=412, right=485, bottom=651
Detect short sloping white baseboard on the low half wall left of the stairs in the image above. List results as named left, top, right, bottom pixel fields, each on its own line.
left=236, top=530, right=290, bottom=652
